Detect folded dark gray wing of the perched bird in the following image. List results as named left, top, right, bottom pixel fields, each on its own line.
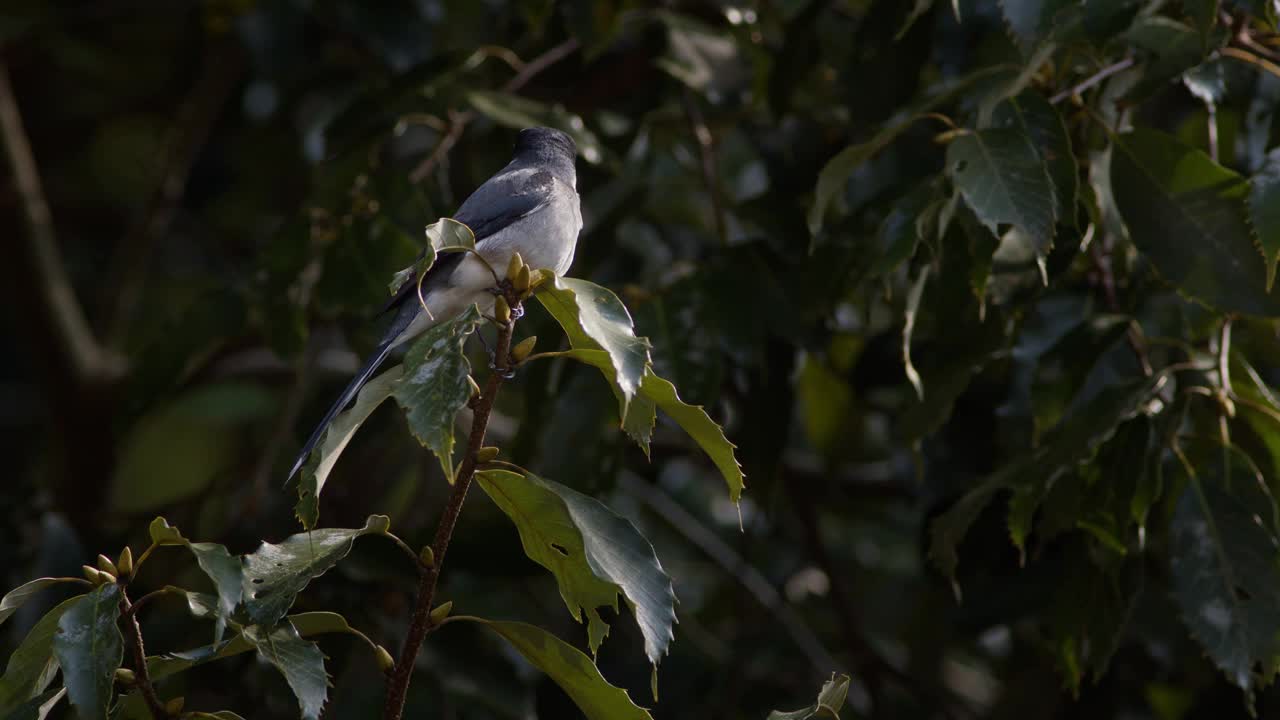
left=378, top=169, right=556, bottom=315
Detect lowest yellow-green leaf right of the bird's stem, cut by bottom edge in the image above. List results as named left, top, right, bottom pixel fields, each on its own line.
left=451, top=615, right=653, bottom=720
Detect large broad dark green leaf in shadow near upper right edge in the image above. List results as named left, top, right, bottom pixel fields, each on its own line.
left=1111, top=129, right=1280, bottom=315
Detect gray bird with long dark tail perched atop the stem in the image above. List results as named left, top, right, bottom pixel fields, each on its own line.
left=289, top=128, right=582, bottom=479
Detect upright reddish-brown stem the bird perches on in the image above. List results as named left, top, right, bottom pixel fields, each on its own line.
left=383, top=283, right=520, bottom=720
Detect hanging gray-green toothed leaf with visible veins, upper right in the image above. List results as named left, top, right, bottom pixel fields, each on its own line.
left=947, top=128, right=1057, bottom=256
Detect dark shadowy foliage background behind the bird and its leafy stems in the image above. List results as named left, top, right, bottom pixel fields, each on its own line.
left=0, top=0, right=1280, bottom=720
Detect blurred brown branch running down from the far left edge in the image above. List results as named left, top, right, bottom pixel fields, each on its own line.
left=0, top=61, right=123, bottom=383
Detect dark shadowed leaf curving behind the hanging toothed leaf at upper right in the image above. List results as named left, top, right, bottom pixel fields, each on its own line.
left=992, top=90, right=1079, bottom=223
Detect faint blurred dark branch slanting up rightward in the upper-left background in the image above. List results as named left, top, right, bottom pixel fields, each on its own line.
left=102, top=42, right=243, bottom=347
